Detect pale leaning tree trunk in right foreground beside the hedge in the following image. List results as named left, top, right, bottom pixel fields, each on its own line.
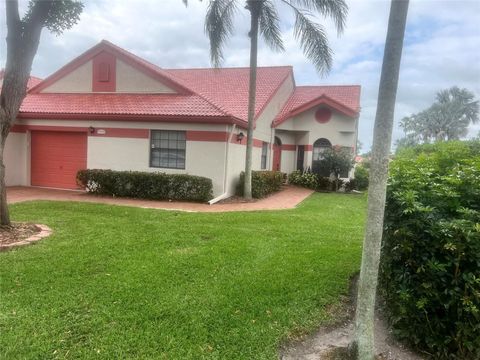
left=356, top=0, right=408, bottom=360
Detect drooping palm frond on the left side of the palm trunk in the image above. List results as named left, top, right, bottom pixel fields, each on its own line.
left=205, top=0, right=237, bottom=67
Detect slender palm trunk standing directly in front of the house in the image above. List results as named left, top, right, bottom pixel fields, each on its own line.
left=243, top=0, right=262, bottom=199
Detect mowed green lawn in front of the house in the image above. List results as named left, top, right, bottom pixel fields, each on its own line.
left=0, top=194, right=366, bottom=359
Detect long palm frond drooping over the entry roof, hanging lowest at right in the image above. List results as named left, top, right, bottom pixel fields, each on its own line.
left=284, top=1, right=332, bottom=74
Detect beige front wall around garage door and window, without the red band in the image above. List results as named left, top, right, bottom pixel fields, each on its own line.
left=14, top=120, right=230, bottom=196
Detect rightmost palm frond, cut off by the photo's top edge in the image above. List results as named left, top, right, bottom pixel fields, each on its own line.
left=289, top=0, right=348, bottom=34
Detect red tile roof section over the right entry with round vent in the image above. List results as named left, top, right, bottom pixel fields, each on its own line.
left=273, top=85, right=360, bottom=126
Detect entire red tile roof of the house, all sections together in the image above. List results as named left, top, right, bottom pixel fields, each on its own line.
left=10, top=40, right=360, bottom=126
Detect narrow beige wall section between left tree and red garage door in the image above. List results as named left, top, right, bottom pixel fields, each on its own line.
left=4, top=132, right=30, bottom=186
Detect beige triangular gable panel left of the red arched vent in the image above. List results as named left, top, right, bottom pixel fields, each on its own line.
left=41, top=60, right=92, bottom=93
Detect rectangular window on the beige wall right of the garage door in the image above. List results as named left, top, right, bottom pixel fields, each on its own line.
left=150, top=130, right=187, bottom=169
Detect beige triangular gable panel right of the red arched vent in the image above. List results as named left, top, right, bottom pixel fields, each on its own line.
left=116, top=59, right=175, bottom=93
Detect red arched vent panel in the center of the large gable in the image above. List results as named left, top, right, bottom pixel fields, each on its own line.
left=92, top=51, right=117, bottom=92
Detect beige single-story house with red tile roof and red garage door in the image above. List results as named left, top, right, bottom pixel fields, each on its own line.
left=5, top=40, right=360, bottom=201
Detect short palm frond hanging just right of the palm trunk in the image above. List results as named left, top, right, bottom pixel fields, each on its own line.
left=259, top=0, right=285, bottom=51
